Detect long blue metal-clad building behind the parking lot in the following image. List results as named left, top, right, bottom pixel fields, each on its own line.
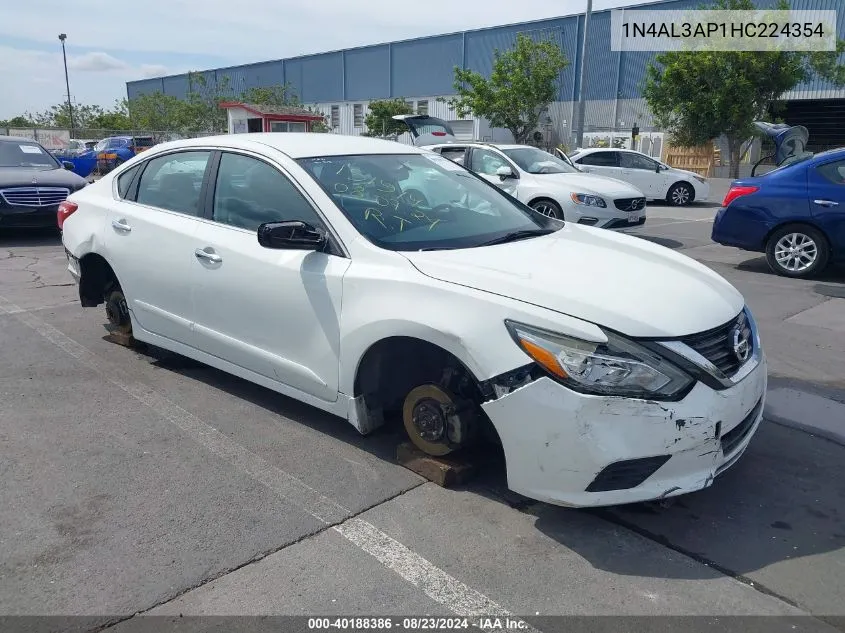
left=126, top=0, right=845, bottom=145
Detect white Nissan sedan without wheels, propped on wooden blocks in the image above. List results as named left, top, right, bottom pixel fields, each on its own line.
left=58, top=133, right=767, bottom=506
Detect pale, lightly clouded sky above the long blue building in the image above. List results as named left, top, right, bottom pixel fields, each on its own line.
left=0, top=0, right=664, bottom=119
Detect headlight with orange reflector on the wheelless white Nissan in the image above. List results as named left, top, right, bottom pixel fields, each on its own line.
left=505, top=321, right=695, bottom=400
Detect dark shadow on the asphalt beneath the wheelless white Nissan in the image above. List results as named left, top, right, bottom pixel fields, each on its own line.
left=125, top=340, right=845, bottom=580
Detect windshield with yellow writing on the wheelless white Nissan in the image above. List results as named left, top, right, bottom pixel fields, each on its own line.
left=298, top=153, right=549, bottom=251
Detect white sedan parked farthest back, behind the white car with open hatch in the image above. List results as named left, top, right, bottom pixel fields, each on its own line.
left=569, top=148, right=710, bottom=206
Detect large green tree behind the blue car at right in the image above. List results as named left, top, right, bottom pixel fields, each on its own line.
left=643, top=0, right=845, bottom=178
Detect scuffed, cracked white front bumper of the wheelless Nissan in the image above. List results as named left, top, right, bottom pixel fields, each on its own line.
left=482, top=356, right=767, bottom=507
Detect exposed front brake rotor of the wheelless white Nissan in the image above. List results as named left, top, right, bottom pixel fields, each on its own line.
left=402, top=385, right=457, bottom=457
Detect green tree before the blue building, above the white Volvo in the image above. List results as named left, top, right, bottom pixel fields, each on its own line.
left=441, top=33, right=569, bottom=143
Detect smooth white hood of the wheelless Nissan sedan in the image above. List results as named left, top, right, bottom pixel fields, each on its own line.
left=402, top=223, right=745, bottom=337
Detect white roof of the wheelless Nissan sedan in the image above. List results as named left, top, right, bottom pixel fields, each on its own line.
left=145, top=132, right=426, bottom=158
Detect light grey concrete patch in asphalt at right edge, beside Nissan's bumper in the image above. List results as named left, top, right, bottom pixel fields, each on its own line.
left=763, top=388, right=845, bottom=446
